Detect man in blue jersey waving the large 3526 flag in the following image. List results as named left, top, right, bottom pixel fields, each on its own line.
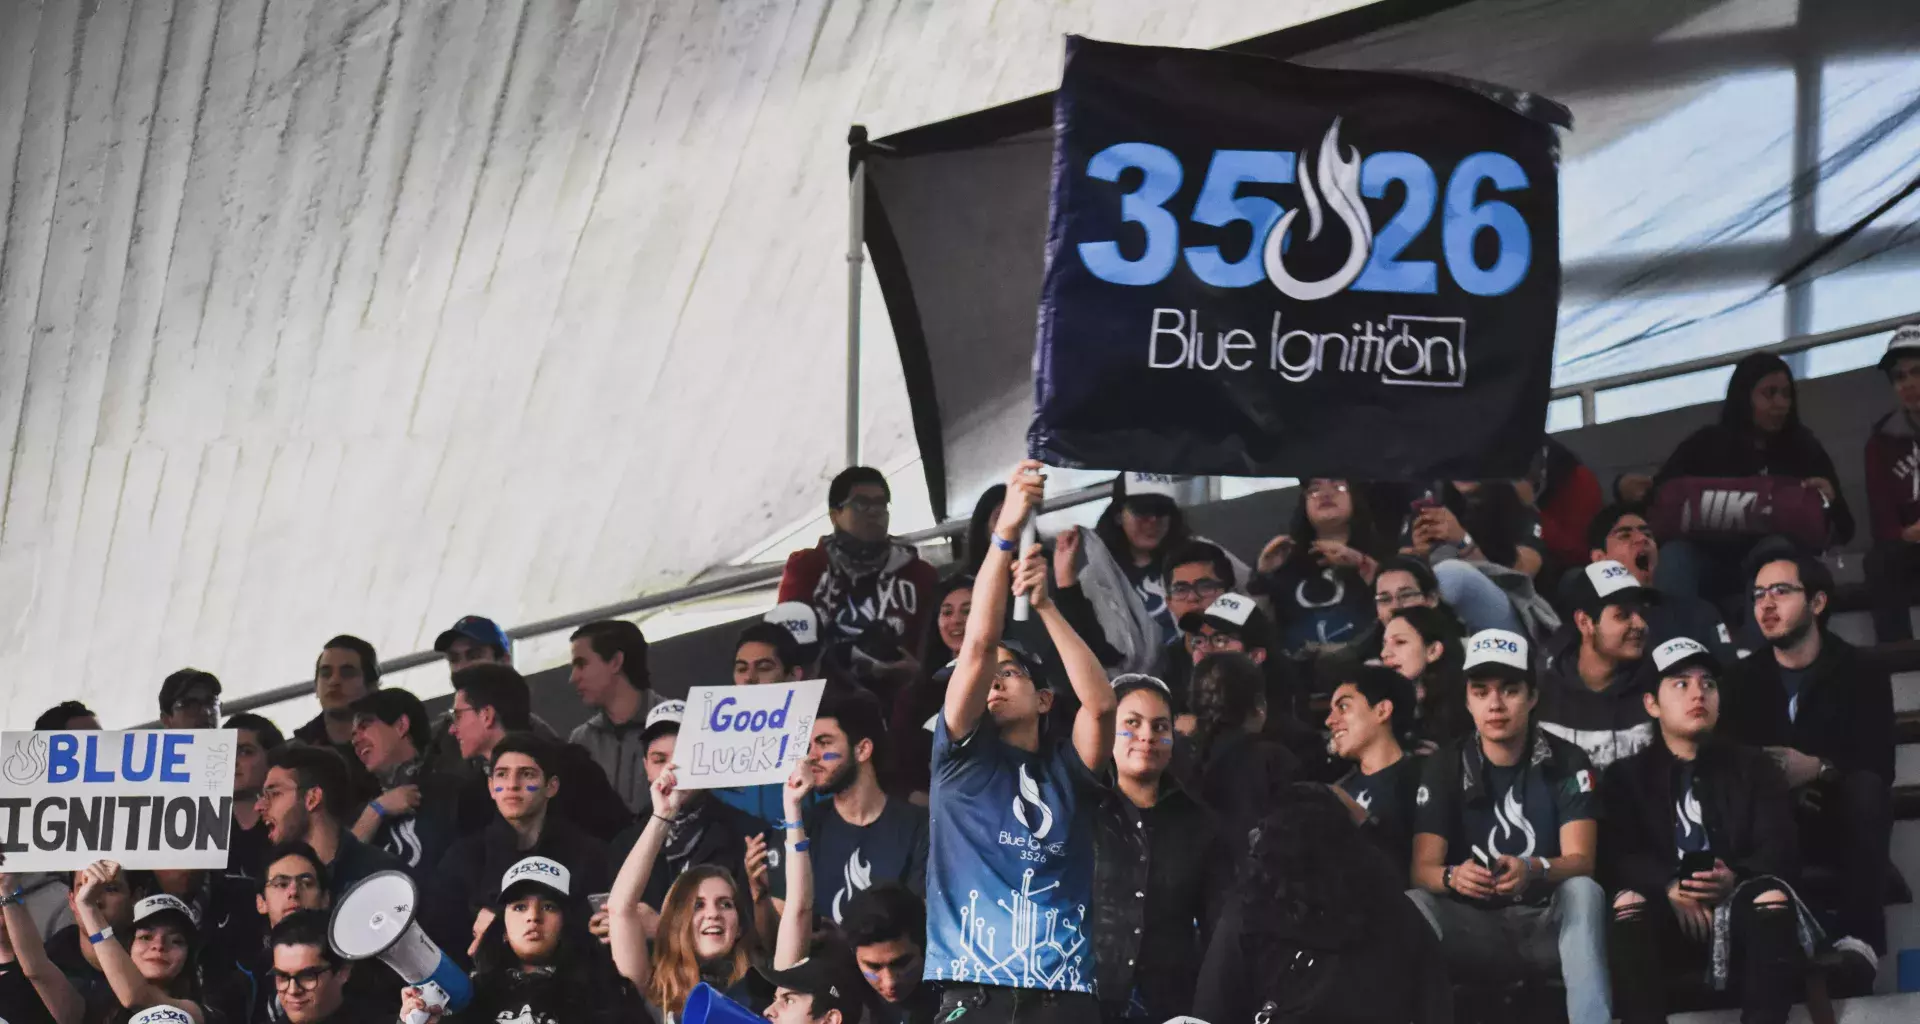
left=925, top=461, right=1116, bottom=1024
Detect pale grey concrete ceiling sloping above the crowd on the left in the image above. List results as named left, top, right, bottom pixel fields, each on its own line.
left=0, top=0, right=1357, bottom=728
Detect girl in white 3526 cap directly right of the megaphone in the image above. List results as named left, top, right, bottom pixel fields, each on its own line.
left=399, top=857, right=622, bottom=1024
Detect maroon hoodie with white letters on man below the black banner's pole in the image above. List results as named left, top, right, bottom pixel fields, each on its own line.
left=780, top=538, right=939, bottom=655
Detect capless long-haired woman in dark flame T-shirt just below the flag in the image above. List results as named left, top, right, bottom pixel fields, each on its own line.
left=1248, top=476, right=1386, bottom=659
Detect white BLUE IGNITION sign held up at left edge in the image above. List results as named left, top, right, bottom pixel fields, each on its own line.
left=0, top=728, right=234, bottom=872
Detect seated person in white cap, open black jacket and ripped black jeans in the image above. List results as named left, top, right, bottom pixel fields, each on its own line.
left=1599, top=636, right=1818, bottom=1024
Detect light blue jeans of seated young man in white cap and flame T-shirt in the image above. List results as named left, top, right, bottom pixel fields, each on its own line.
left=1407, top=878, right=1613, bottom=1024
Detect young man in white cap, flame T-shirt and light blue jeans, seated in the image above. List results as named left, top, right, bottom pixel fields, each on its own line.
left=1409, top=630, right=1613, bottom=1024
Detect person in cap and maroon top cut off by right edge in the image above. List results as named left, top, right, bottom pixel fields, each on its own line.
left=1864, top=323, right=1920, bottom=644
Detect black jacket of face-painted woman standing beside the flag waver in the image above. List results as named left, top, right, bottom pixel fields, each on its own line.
left=1092, top=768, right=1236, bottom=1020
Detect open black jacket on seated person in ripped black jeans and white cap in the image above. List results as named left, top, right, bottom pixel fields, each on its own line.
left=1599, top=740, right=1799, bottom=899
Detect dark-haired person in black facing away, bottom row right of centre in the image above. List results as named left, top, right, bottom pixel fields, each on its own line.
left=1192, top=784, right=1453, bottom=1024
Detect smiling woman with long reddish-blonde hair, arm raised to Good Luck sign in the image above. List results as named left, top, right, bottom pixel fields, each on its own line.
left=607, top=765, right=766, bottom=1024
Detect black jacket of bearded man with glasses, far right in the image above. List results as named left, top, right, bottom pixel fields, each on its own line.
left=1720, top=628, right=1893, bottom=786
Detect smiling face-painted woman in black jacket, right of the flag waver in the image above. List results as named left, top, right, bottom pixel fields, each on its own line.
left=1092, top=674, right=1233, bottom=1022
